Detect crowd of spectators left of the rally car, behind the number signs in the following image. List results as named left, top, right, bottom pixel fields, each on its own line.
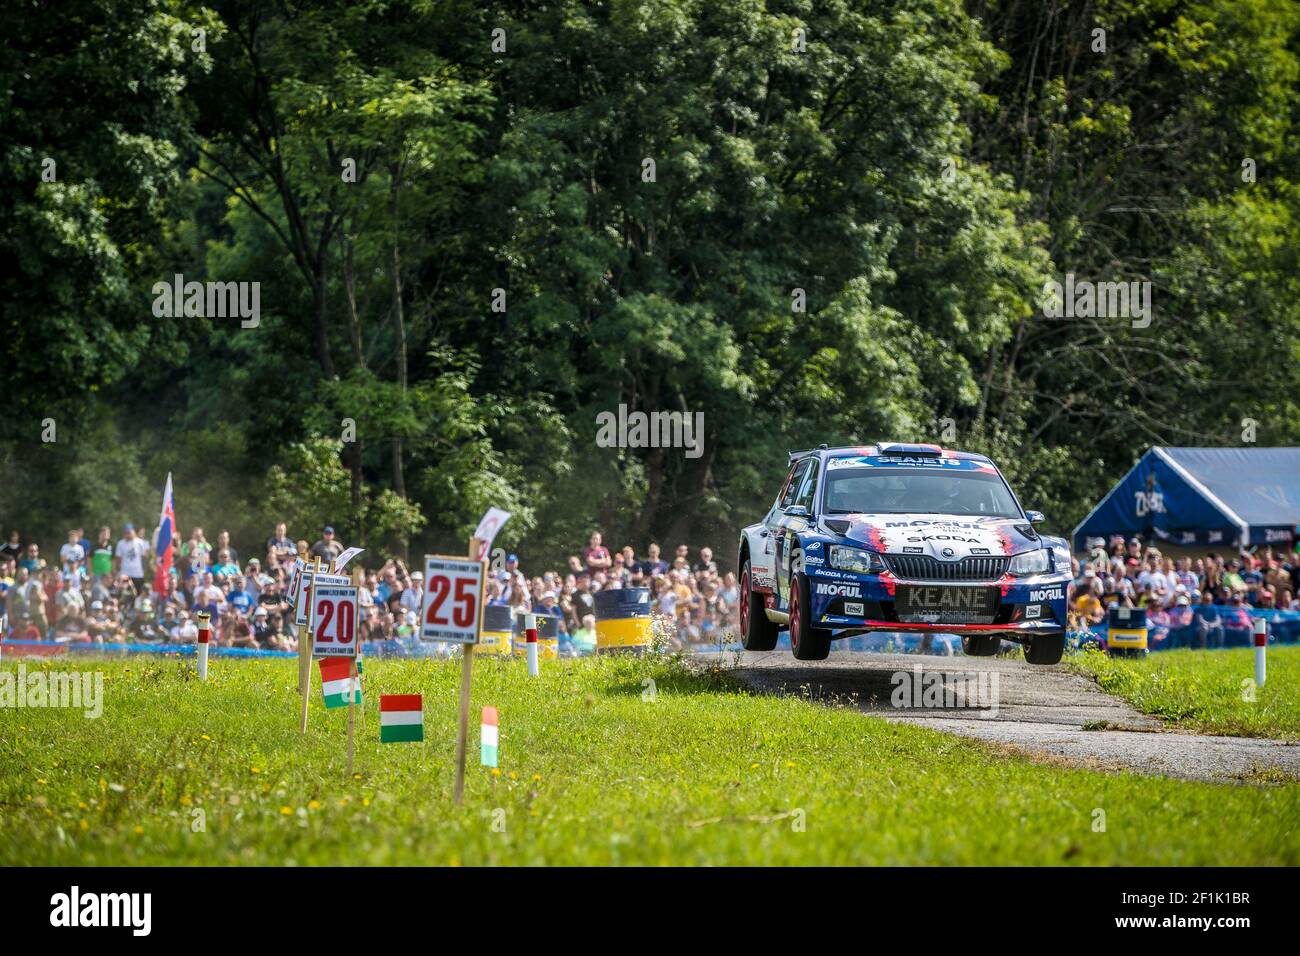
left=0, top=524, right=740, bottom=654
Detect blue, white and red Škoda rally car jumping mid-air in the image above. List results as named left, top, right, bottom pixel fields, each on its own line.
left=740, top=442, right=1071, bottom=663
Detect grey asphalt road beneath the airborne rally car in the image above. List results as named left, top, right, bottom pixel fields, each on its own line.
left=709, top=652, right=1300, bottom=780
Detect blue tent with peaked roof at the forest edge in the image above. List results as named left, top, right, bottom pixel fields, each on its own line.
left=1074, top=447, right=1300, bottom=551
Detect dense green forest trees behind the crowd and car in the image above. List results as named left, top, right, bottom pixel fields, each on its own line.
left=0, top=0, right=1300, bottom=562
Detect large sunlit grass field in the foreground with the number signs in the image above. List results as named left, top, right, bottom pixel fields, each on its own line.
left=0, top=658, right=1300, bottom=865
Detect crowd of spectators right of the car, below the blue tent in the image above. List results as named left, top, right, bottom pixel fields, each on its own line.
left=1067, top=535, right=1300, bottom=646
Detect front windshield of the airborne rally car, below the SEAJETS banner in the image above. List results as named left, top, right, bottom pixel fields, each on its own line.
left=826, top=468, right=1022, bottom=518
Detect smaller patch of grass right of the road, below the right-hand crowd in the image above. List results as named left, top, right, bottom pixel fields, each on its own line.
left=1070, top=645, right=1300, bottom=740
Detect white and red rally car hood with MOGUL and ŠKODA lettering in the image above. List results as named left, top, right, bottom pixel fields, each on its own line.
left=832, top=515, right=1041, bottom=561
